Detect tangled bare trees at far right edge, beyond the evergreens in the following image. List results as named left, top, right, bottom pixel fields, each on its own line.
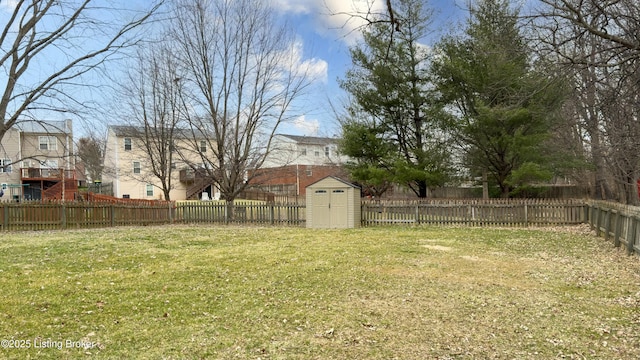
left=539, top=0, right=640, bottom=204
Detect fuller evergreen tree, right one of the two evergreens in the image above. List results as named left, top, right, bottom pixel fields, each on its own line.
left=434, top=0, right=562, bottom=197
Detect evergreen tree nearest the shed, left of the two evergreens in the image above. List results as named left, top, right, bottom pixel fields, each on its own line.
left=341, top=0, right=448, bottom=198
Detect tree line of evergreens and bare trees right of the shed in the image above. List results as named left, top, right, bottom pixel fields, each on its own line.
left=341, top=0, right=640, bottom=204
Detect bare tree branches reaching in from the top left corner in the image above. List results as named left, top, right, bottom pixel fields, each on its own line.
left=0, top=0, right=159, bottom=139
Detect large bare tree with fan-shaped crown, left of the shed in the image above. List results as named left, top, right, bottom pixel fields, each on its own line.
left=173, top=0, right=309, bottom=214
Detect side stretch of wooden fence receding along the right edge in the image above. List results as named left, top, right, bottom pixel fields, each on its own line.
left=587, top=201, right=640, bottom=254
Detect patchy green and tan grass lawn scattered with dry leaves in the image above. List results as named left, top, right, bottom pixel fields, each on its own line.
left=0, top=226, right=640, bottom=359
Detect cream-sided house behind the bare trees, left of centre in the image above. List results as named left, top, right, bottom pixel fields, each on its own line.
left=102, top=126, right=216, bottom=200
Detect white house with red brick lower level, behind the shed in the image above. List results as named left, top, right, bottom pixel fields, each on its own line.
left=250, top=134, right=348, bottom=195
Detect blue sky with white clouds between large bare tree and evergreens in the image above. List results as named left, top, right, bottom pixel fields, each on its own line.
left=274, top=0, right=467, bottom=136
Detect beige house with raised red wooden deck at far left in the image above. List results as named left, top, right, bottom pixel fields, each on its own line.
left=0, top=120, right=78, bottom=201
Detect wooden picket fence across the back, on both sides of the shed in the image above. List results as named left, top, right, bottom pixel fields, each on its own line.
left=0, top=199, right=592, bottom=232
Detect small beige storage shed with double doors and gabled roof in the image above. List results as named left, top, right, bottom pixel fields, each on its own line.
left=306, top=176, right=361, bottom=228
